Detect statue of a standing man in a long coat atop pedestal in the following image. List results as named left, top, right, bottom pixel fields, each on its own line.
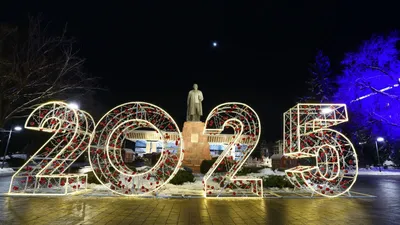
left=186, top=84, right=204, bottom=121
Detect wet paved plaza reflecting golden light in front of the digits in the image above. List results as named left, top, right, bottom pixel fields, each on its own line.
left=0, top=176, right=400, bottom=225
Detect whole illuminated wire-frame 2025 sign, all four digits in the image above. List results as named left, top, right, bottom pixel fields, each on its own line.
left=9, top=102, right=357, bottom=197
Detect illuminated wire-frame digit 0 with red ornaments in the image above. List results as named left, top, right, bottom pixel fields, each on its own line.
left=89, top=102, right=184, bottom=196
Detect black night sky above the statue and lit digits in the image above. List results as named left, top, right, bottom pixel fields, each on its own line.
left=0, top=0, right=400, bottom=141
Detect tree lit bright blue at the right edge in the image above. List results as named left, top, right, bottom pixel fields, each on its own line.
left=335, top=32, right=400, bottom=139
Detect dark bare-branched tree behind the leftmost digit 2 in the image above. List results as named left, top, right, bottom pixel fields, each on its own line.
left=0, top=17, right=97, bottom=128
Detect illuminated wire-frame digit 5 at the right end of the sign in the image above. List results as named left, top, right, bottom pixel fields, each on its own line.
left=283, top=104, right=358, bottom=197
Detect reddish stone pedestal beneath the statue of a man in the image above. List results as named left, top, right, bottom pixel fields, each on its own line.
left=182, top=121, right=211, bottom=173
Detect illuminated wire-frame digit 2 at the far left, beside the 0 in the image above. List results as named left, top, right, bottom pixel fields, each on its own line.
left=9, top=101, right=94, bottom=195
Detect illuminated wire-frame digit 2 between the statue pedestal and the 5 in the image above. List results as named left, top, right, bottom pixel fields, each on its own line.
left=203, top=102, right=263, bottom=197
